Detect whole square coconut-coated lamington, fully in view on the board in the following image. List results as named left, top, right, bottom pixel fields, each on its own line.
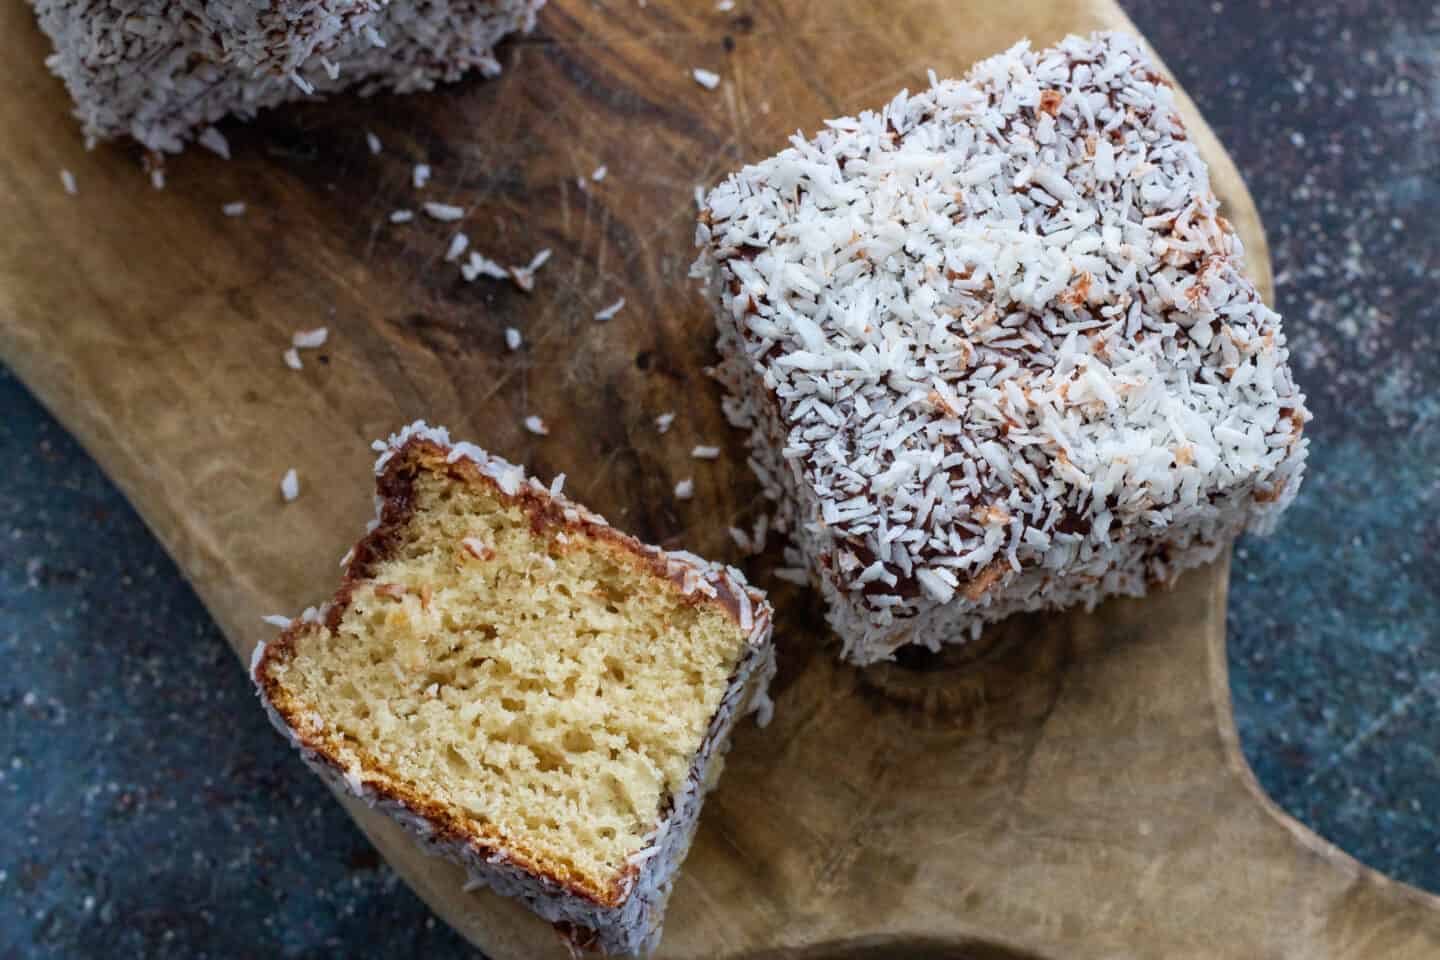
left=696, top=33, right=1309, bottom=662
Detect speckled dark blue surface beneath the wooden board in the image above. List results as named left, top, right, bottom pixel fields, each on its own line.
left=0, top=0, right=1440, bottom=957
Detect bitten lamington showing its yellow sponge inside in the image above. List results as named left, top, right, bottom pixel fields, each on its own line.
left=252, top=423, right=773, bottom=953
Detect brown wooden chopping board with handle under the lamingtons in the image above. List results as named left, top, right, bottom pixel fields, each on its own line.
left=0, top=0, right=1440, bottom=960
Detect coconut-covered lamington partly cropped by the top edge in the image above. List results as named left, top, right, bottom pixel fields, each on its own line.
left=30, top=0, right=544, bottom=153
